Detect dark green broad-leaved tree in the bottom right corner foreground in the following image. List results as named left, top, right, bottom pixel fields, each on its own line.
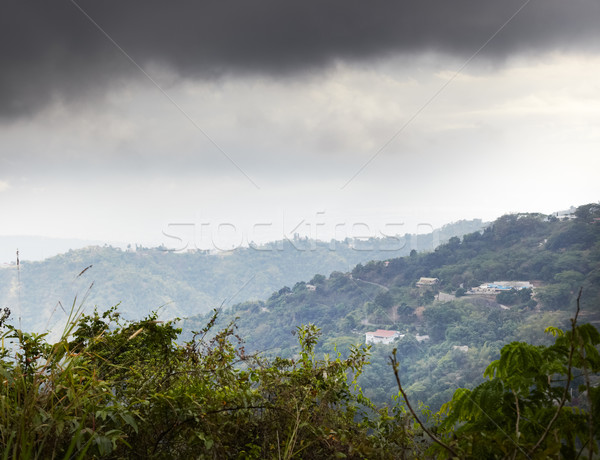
left=438, top=292, right=600, bottom=459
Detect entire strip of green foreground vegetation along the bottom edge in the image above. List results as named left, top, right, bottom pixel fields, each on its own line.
left=0, top=299, right=600, bottom=459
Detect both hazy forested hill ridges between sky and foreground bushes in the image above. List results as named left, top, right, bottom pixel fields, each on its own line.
left=0, top=204, right=600, bottom=409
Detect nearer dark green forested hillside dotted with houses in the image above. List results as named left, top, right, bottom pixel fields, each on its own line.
left=184, top=205, right=600, bottom=409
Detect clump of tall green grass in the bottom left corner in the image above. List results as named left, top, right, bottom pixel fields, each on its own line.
left=0, top=292, right=134, bottom=459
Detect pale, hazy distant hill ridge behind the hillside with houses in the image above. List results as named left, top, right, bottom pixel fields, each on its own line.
left=0, top=220, right=485, bottom=331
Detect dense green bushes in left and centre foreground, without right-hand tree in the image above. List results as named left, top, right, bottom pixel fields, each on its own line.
left=0, top=309, right=419, bottom=459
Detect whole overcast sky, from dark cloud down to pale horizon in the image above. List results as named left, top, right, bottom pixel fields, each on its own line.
left=0, top=0, right=600, bottom=255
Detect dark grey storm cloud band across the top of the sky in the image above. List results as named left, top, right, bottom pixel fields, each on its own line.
left=0, top=0, right=600, bottom=117
